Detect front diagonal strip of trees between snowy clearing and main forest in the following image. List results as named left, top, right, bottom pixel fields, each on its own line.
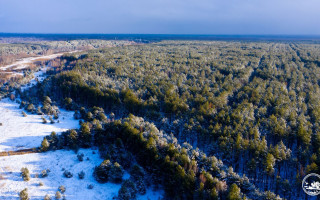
left=40, top=111, right=277, bottom=199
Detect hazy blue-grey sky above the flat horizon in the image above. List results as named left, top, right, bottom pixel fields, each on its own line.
left=0, top=0, right=320, bottom=35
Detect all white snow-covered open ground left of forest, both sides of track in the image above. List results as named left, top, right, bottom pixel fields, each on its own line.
left=0, top=60, right=163, bottom=200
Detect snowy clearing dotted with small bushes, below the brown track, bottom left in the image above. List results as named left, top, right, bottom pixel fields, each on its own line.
left=0, top=149, right=160, bottom=200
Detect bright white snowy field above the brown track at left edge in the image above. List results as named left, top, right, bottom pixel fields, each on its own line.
left=0, top=98, right=79, bottom=151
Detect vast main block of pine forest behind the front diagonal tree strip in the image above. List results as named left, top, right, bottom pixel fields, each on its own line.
left=20, top=41, right=320, bottom=199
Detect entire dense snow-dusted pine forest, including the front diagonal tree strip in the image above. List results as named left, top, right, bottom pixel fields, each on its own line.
left=16, top=41, right=320, bottom=199
